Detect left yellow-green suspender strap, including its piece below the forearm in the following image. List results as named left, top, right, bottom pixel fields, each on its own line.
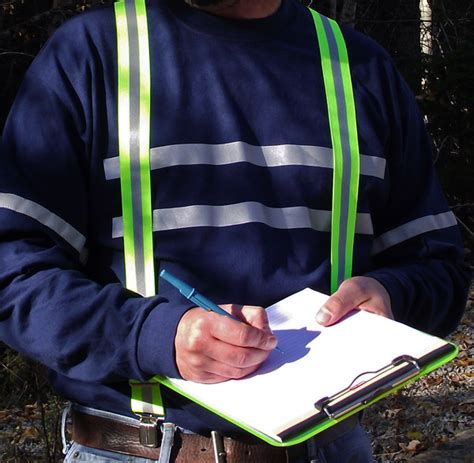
left=115, top=0, right=165, bottom=417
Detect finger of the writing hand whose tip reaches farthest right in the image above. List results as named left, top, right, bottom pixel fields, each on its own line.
left=210, top=314, right=277, bottom=350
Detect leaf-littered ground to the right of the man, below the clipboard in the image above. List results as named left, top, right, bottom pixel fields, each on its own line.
left=364, top=290, right=474, bottom=463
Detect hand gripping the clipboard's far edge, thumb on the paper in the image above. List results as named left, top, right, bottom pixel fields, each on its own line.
left=316, top=277, right=394, bottom=326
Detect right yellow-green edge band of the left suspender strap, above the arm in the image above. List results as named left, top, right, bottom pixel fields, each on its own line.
left=136, top=0, right=155, bottom=296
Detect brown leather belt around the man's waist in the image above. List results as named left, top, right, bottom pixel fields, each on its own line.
left=71, top=408, right=358, bottom=463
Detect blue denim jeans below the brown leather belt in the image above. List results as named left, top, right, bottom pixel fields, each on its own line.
left=64, top=425, right=374, bottom=463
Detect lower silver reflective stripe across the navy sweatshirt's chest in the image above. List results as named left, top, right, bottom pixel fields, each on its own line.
left=112, top=202, right=373, bottom=238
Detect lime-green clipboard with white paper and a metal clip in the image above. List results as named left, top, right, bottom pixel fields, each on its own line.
left=153, top=289, right=458, bottom=447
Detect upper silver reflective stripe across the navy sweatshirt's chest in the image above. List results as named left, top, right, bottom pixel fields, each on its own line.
left=104, top=141, right=386, bottom=180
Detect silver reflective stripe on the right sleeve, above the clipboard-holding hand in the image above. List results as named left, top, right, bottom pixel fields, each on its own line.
left=372, top=211, right=457, bottom=255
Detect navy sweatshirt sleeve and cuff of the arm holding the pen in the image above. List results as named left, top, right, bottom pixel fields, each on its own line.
left=0, top=15, right=189, bottom=382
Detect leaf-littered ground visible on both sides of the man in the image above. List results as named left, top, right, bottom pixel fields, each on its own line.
left=0, top=289, right=474, bottom=463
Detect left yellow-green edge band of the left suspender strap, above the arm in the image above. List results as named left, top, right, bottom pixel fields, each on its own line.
left=115, top=2, right=137, bottom=291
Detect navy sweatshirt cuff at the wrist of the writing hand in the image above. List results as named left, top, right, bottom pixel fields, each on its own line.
left=137, top=301, right=195, bottom=378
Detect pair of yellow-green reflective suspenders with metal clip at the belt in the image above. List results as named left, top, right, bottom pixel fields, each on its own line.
left=115, top=0, right=360, bottom=442
